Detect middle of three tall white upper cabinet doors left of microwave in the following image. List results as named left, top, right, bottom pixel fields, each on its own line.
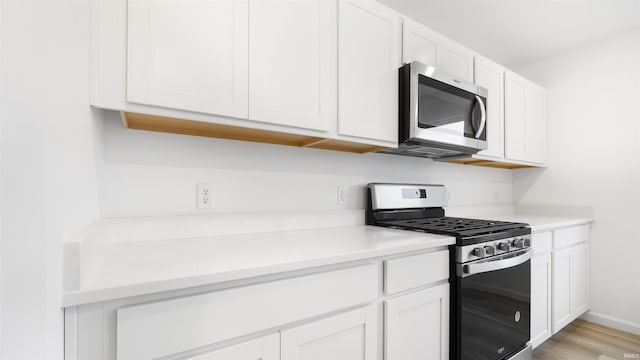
left=249, top=0, right=338, bottom=131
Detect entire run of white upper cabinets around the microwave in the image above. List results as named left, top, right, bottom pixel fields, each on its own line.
left=96, top=0, right=546, bottom=159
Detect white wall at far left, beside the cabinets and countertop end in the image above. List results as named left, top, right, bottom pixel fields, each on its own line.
left=0, top=0, right=101, bottom=360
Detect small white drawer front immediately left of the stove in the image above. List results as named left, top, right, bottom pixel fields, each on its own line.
left=384, top=250, right=449, bottom=295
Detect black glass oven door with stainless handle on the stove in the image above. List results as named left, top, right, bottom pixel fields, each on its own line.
left=454, top=248, right=532, bottom=360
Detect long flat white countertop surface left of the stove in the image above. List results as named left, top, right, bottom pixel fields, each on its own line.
left=62, top=225, right=455, bottom=307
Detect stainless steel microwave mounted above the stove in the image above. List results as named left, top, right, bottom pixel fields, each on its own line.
left=382, top=62, right=488, bottom=159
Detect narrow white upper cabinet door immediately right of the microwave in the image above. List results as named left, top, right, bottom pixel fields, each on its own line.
left=474, top=56, right=504, bottom=159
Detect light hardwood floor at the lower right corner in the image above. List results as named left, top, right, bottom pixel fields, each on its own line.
left=533, top=319, right=640, bottom=360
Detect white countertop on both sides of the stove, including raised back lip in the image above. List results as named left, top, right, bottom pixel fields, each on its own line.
left=62, top=211, right=593, bottom=307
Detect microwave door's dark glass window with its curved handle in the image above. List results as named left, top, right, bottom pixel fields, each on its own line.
left=418, top=75, right=482, bottom=139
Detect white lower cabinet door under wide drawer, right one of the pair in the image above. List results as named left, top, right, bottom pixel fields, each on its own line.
left=281, top=305, right=378, bottom=360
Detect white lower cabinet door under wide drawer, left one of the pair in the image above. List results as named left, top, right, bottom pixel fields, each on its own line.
left=186, top=334, right=280, bottom=360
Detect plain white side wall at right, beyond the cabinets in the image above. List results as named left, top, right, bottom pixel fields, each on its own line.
left=513, top=31, right=640, bottom=332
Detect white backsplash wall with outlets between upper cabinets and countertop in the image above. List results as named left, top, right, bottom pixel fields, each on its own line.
left=100, top=111, right=512, bottom=217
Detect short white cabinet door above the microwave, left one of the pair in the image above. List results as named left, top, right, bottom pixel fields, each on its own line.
left=402, top=19, right=443, bottom=68
